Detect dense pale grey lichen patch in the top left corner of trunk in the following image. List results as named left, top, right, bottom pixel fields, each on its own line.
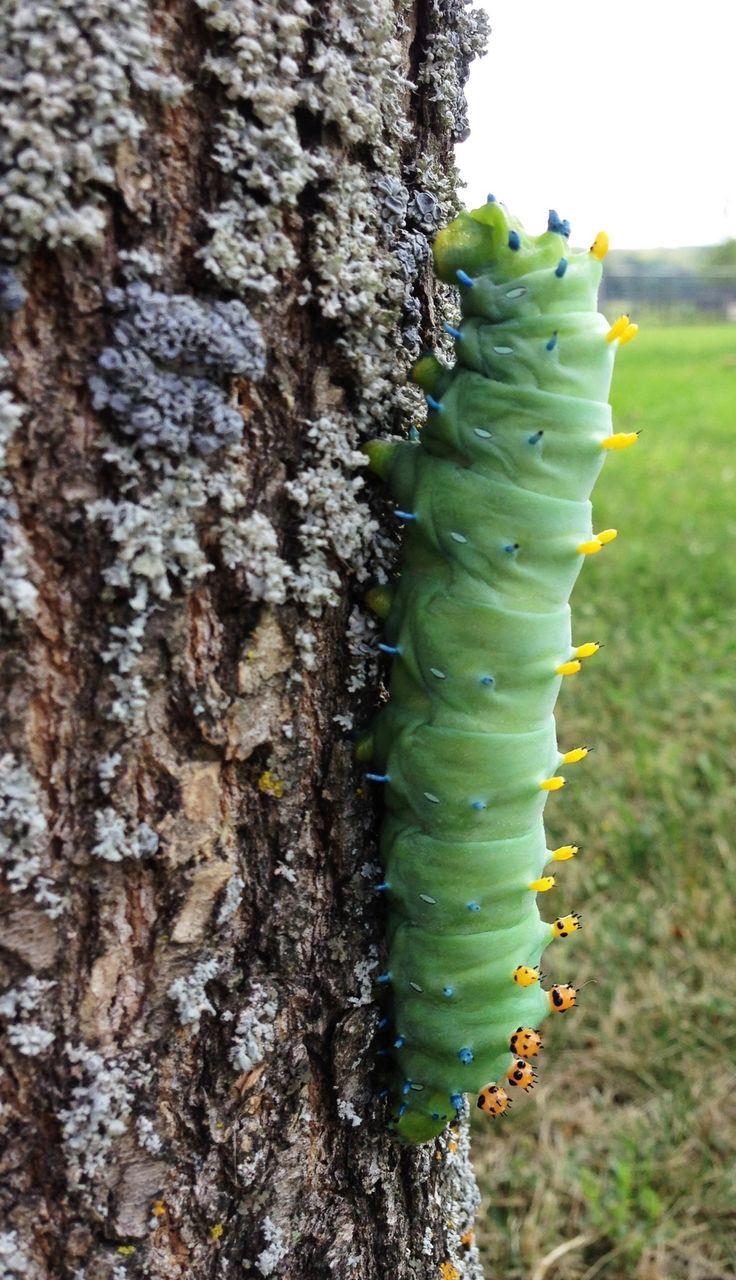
left=0, top=0, right=183, bottom=257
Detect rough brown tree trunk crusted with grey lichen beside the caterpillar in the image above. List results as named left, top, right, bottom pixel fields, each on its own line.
left=0, top=0, right=491, bottom=1280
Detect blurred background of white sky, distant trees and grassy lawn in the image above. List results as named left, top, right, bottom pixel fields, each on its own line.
left=458, top=0, right=736, bottom=1280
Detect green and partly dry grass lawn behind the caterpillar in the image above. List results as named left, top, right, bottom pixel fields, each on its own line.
left=474, top=325, right=736, bottom=1280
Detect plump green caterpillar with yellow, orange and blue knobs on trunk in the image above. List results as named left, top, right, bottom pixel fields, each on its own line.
left=358, top=197, right=636, bottom=1142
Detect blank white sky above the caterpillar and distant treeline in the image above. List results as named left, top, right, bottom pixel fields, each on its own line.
left=457, top=0, right=736, bottom=248
